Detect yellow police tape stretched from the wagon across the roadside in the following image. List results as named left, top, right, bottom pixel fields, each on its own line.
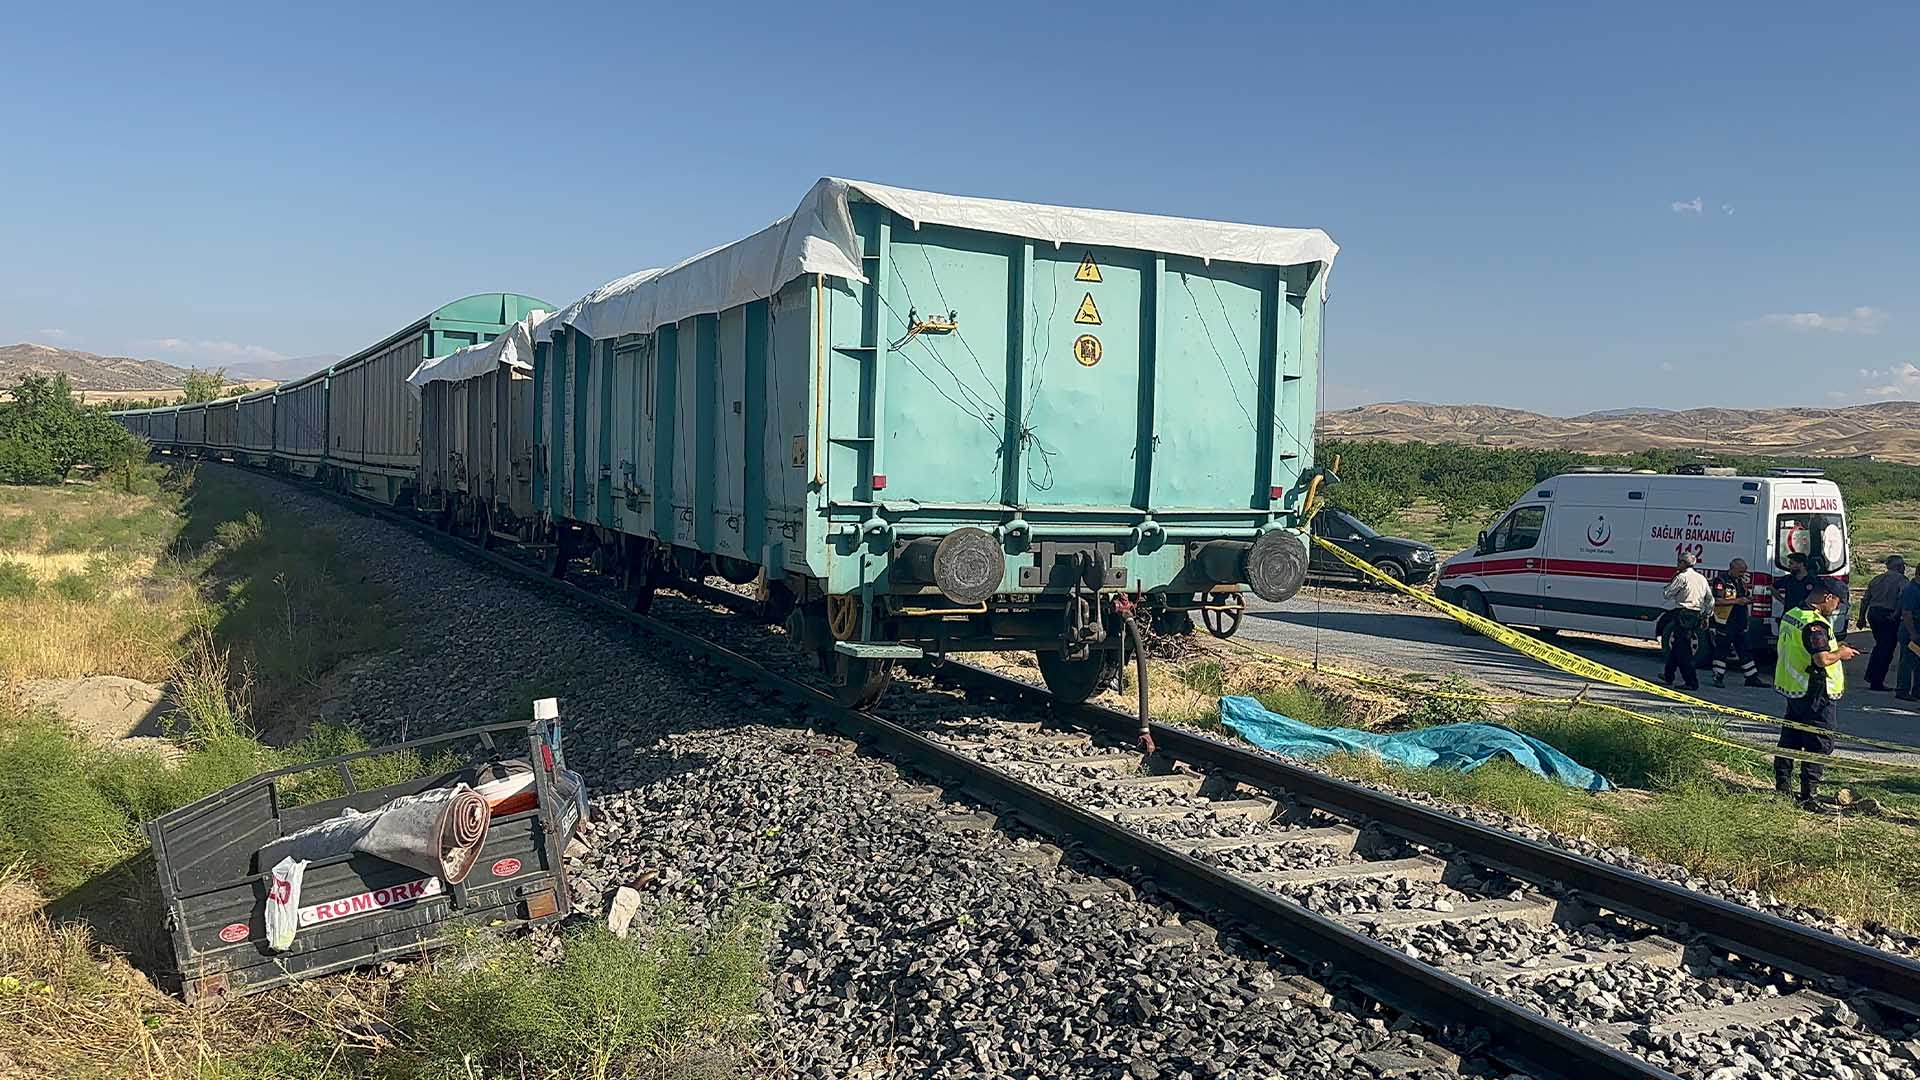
left=1290, top=536, right=1920, bottom=773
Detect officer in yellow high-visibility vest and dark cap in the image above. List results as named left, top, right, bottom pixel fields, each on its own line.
left=1774, top=580, right=1860, bottom=809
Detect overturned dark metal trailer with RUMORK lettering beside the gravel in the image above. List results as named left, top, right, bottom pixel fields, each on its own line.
left=146, top=700, right=586, bottom=1001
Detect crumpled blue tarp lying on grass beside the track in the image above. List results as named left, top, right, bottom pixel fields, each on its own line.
left=1219, top=698, right=1613, bottom=792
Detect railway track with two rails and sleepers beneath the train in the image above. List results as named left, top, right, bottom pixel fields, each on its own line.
left=198, top=455, right=1920, bottom=1080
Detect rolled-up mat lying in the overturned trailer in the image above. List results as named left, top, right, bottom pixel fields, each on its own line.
left=259, top=784, right=492, bottom=884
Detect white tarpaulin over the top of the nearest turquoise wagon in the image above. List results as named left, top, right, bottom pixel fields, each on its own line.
left=534, top=177, right=1340, bottom=340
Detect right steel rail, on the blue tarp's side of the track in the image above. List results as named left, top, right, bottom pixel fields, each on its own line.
left=937, top=661, right=1920, bottom=1017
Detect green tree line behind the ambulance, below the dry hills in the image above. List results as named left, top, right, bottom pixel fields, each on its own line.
left=1315, top=438, right=1920, bottom=521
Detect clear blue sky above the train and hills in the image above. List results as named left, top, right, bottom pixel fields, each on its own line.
left=0, top=0, right=1920, bottom=413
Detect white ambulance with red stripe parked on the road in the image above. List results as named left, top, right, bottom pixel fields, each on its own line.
left=1434, top=465, right=1853, bottom=650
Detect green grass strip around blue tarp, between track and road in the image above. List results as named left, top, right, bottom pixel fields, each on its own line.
left=1181, top=661, right=1920, bottom=930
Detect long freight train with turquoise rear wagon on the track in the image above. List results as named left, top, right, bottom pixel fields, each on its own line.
left=119, top=179, right=1338, bottom=705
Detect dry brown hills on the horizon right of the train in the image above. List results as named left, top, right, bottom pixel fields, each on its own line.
left=1319, top=402, right=1920, bottom=465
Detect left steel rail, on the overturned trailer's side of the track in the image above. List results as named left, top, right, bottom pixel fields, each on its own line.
left=214, top=466, right=1676, bottom=1080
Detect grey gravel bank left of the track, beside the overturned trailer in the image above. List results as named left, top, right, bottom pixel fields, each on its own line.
left=228, top=469, right=1451, bottom=1080
